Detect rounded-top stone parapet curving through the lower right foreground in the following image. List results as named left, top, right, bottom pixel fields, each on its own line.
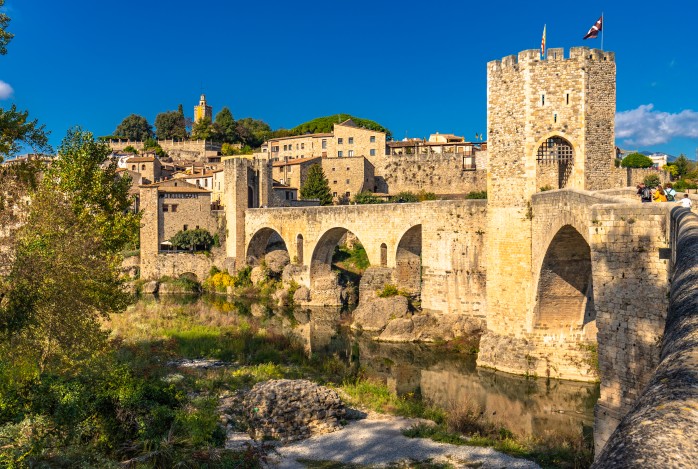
left=592, top=207, right=698, bottom=468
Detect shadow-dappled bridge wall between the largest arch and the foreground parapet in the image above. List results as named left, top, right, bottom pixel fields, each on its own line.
left=590, top=203, right=675, bottom=452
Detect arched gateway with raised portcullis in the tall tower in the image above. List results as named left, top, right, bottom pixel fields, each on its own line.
left=536, top=136, right=574, bottom=189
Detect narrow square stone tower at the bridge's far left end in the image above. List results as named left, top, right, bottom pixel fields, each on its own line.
left=223, top=158, right=273, bottom=267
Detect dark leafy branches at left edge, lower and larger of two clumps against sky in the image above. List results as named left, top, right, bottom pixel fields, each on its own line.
left=0, top=103, right=52, bottom=163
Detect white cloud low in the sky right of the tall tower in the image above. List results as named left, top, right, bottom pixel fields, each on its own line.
left=616, top=104, right=698, bottom=145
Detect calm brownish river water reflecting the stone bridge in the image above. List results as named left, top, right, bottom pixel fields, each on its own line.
left=144, top=297, right=599, bottom=435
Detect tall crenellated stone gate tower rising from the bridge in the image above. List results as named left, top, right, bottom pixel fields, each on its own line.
left=480, top=47, right=616, bottom=372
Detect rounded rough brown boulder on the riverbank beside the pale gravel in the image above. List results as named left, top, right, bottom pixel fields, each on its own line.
left=243, top=379, right=346, bottom=442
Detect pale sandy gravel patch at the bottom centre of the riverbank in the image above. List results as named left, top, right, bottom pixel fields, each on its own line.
left=269, top=413, right=539, bottom=469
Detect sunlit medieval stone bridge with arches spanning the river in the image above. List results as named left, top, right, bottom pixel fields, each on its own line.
left=238, top=189, right=673, bottom=454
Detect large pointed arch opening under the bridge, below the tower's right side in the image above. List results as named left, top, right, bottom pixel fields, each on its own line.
left=534, top=225, right=596, bottom=336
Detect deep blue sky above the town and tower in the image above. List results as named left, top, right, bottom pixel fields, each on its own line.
left=0, top=0, right=698, bottom=158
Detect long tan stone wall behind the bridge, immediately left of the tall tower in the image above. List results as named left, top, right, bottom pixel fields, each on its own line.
left=369, top=152, right=487, bottom=194
